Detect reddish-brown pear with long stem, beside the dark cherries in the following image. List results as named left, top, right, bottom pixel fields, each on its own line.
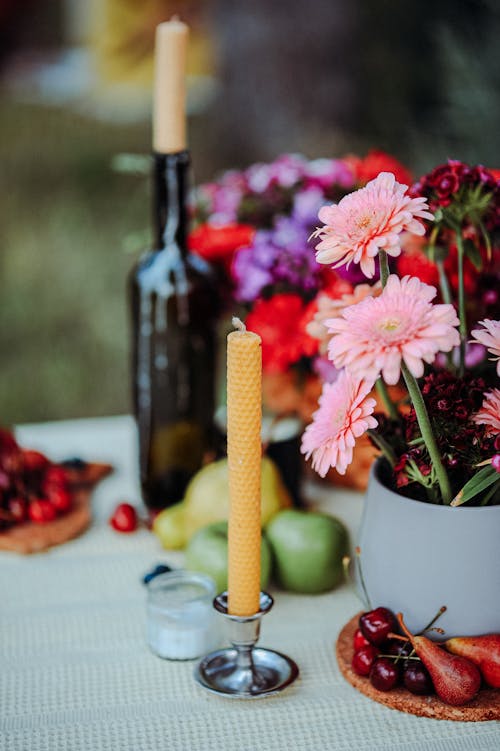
left=398, top=613, right=481, bottom=707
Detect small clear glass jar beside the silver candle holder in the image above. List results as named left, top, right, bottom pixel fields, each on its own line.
left=147, top=570, right=219, bottom=660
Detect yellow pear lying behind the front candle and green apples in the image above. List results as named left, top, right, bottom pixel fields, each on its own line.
left=153, top=456, right=292, bottom=549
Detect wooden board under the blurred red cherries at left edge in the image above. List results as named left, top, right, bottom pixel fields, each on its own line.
left=0, top=463, right=113, bottom=555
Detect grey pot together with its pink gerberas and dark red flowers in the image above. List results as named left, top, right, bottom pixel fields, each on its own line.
left=296, top=162, right=500, bottom=636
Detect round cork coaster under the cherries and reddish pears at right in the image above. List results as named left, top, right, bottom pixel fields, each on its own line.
left=336, top=613, right=500, bottom=722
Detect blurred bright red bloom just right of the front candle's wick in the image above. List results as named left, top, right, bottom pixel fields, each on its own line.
left=246, top=293, right=318, bottom=373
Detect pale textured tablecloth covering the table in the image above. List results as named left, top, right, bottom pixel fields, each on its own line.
left=0, top=417, right=500, bottom=751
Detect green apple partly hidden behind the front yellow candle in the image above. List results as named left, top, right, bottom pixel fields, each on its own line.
left=185, top=522, right=271, bottom=592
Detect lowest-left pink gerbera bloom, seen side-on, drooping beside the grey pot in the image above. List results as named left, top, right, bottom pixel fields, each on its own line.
left=301, top=370, right=378, bottom=477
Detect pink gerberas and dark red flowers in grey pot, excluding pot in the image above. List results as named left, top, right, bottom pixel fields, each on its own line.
left=302, top=161, right=500, bottom=506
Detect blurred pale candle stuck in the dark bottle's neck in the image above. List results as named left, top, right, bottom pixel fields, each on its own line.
left=153, top=18, right=189, bottom=154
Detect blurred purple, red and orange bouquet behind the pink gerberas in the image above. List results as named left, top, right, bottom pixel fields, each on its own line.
left=190, top=151, right=411, bottom=487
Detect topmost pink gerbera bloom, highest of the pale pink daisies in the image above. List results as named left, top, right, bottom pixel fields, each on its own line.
left=314, top=172, right=434, bottom=279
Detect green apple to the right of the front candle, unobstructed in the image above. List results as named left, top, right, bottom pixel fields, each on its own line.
left=266, top=509, right=348, bottom=594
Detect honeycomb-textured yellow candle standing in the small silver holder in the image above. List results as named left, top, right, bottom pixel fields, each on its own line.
left=227, top=318, right=262, bottom=616
